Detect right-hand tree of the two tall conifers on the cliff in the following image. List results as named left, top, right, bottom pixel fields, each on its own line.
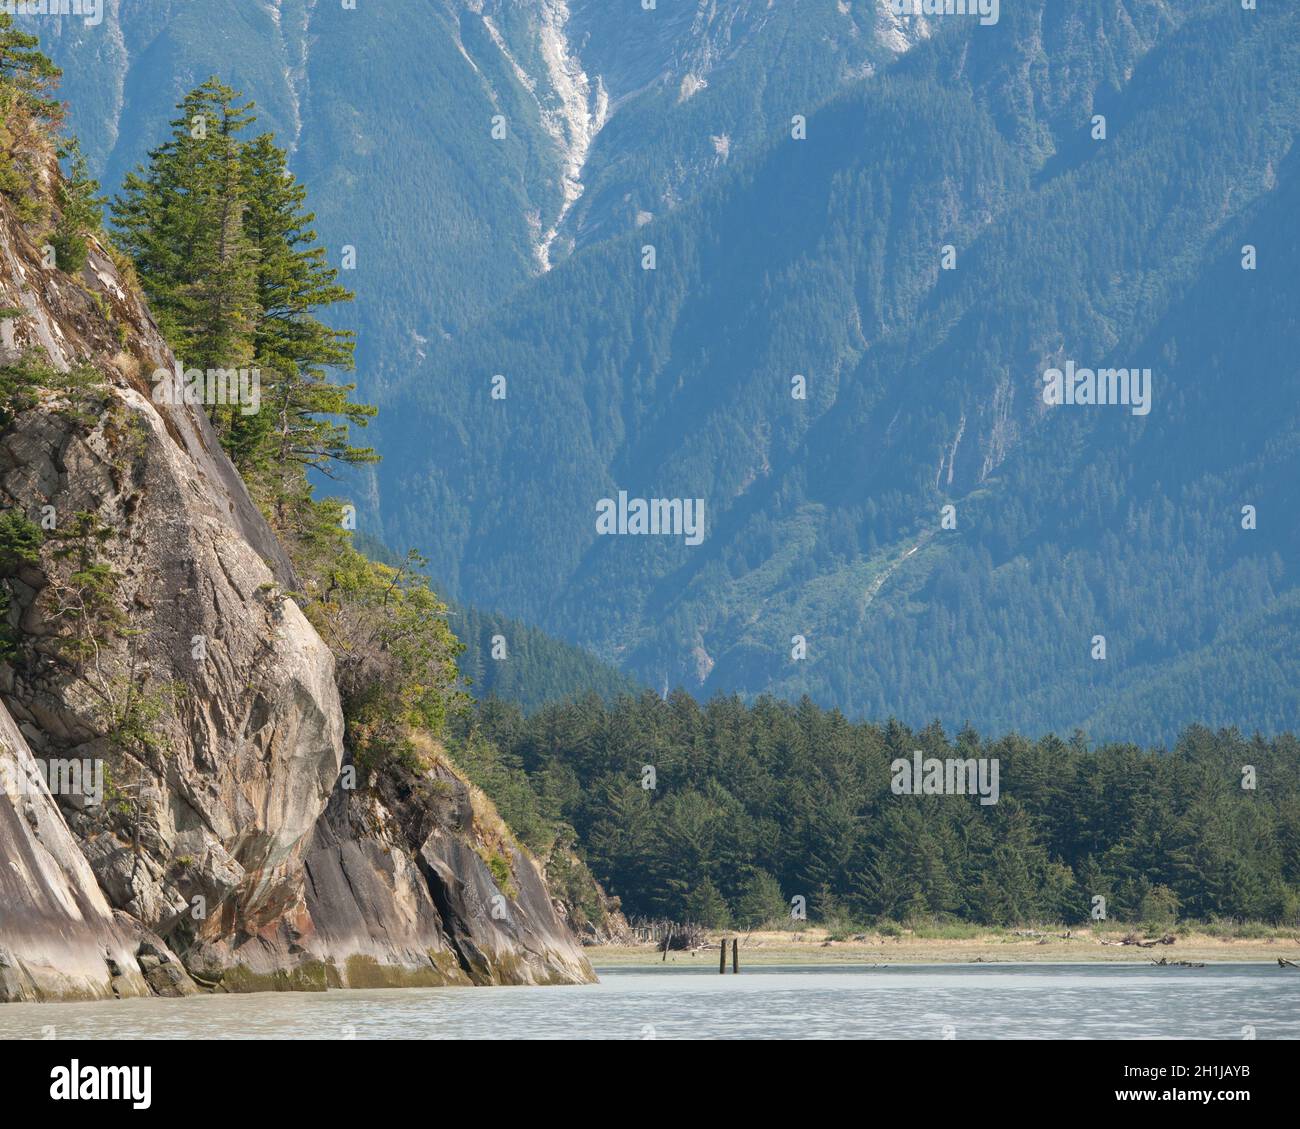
left=237, top=134, right=377, bottom=525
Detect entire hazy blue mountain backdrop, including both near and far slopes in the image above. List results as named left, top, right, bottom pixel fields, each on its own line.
left=42, top=0, right=1300, bottom=740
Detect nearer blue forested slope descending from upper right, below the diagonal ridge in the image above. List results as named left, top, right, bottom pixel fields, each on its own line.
left=380, top=3, right=1300, bottom=740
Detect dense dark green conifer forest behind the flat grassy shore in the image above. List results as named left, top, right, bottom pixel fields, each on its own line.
left=457, top=692, right=1300, bottom=927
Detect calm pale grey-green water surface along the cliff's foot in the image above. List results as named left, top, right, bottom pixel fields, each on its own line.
left=0, top=964, right=1300, bottom=1039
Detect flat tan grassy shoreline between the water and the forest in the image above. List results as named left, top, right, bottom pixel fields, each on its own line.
left=585, top=926, right=1300, bottom=977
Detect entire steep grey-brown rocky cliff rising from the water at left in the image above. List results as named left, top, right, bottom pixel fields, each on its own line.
left=0, top=165, right=593, bottom=1000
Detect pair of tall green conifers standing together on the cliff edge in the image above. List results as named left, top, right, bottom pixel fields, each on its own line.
left=113, top=78, right=376, bottom=515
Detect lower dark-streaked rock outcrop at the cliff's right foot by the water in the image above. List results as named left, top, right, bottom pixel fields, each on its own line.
left=307, top=764, right=594, bottom=987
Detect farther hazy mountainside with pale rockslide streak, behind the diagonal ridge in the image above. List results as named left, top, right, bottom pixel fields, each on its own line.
left=35, top=0, right=928, bottom=402
